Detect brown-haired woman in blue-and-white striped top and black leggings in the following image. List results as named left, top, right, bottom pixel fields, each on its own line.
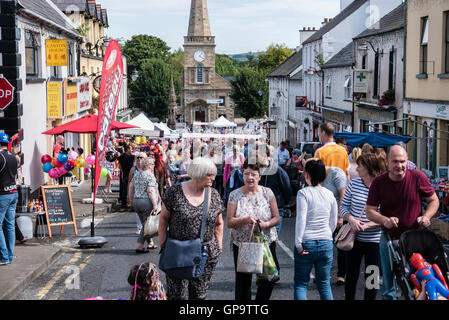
left=341, top=153, right=383, bottom=300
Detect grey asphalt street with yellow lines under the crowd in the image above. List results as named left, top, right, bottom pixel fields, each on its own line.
left=17, top=213, right=368, bottom=300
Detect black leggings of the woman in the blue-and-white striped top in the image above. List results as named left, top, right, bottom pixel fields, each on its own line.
left=345, top=240, right=379, bottom=300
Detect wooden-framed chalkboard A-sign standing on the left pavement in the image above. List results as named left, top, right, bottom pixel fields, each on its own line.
left=41, top=185, right=78, bottom=238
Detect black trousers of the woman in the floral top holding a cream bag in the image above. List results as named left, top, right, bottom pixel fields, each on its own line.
left=232, top=241, right=277, bottom=301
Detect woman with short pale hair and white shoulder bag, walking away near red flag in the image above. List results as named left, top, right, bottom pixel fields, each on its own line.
left=129, top=158, right=161, bottom=253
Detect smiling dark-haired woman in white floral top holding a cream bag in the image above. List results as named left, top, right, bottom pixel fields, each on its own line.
left=226, top=161, right=279, bottom=300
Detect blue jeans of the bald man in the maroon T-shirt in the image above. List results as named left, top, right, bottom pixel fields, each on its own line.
left=379, top=232, right=396, bottom=300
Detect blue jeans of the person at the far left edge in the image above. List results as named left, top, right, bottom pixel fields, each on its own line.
left=0, top=193, right=18, bottom=263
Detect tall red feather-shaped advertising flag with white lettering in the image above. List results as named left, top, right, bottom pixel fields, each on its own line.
left=92, top=40, right=123, bottom=208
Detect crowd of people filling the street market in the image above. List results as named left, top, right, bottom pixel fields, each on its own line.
left=103, top=123, right=439, bottom=300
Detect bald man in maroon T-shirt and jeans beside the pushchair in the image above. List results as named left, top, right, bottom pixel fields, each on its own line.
left=366, top=144, right=439, bottom=300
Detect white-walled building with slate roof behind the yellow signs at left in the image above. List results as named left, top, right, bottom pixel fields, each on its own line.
left=18, top=0, right=82, bottom=191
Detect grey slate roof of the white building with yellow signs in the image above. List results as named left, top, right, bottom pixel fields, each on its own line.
left=17, top=0, right=79, bottom=34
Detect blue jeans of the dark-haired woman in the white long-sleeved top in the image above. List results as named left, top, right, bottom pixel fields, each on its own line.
left=293, top=240, right=334, bottom=300
